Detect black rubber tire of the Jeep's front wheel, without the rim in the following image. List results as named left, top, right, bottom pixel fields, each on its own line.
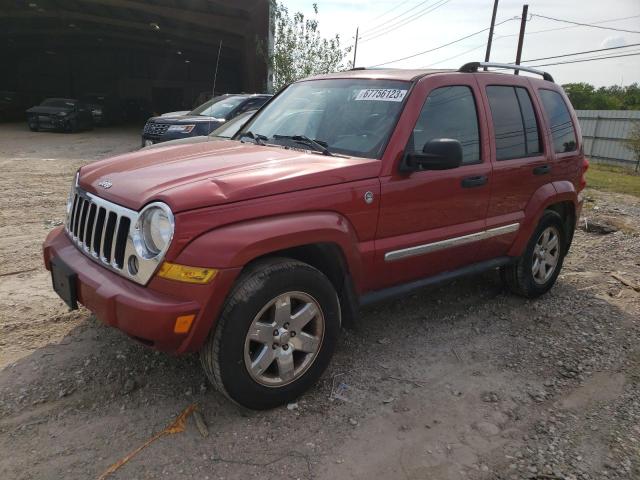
left=200, top=258, right=341, bottom=410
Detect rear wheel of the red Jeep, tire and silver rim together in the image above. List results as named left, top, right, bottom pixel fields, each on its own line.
left=500, top=210, right=567, bottom=298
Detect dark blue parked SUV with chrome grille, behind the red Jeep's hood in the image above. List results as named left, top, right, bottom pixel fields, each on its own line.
left=142, top=94, right=271, bottom=147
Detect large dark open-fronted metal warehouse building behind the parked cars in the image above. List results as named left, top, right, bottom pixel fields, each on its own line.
left=0, top=0, right=269, bottom=112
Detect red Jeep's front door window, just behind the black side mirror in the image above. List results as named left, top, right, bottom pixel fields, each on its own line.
left=412, top=86, right=480, bottom=165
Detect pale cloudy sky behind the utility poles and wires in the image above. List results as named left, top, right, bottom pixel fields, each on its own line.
left=281, top=0, right=640, bottom=87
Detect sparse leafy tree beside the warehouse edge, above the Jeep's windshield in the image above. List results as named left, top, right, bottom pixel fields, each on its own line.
left=259, top=0, right=351, bottom=91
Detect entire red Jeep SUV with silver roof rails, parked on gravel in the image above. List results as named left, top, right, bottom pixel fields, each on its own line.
left=44, top=63, right=588, bottom=409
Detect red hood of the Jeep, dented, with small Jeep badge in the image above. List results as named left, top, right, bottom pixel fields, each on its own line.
left=79, top=140, right=381, bottom=213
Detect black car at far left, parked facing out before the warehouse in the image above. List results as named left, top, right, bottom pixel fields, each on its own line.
left=27, top=98, right=93, bottom=132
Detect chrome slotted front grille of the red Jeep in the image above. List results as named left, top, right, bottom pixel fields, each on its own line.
left=65, top=187, right=162, bottom=284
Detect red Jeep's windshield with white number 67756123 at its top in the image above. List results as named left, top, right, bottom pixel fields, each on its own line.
left=236, top=79, right=410, bottom=158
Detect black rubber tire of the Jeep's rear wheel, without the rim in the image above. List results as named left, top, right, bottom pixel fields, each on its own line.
left=500, top=210, right=567, bottom=298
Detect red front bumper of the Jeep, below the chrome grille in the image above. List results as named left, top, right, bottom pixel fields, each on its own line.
left=43, top=227, right=240, bottom=354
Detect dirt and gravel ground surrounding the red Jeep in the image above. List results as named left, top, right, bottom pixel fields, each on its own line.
left=0, top=124, right=640, bottom=480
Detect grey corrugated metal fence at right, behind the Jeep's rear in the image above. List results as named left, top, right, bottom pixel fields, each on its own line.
left=576, top=110, right=640, bottom=166
